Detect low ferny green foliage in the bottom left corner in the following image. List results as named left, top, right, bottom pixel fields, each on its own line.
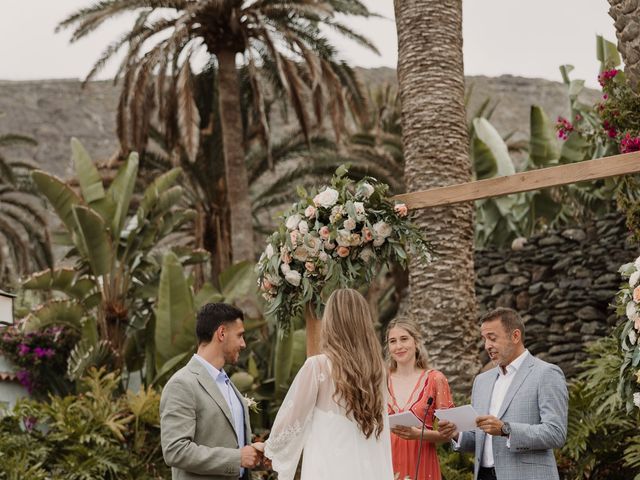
left=0, top=369, right=170, bottom=480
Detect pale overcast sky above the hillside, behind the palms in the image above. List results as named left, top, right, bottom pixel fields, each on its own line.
left=0, top=0, right=615, bottom=86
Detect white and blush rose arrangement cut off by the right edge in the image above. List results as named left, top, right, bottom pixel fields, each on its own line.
left=616, top=257, right=640, bottom=411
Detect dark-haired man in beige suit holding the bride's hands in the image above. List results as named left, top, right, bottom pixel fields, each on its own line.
left=160, top=303, right=262, bottom=480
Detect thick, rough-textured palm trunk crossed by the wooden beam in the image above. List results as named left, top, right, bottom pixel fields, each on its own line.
left=394, top=0, right=479, bottom=390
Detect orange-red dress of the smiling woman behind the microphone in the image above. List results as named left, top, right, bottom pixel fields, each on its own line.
left=387, top=370, right=453, bottom=480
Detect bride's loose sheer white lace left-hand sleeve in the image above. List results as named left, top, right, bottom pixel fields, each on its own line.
left=265, top=357, right=325, bottom=480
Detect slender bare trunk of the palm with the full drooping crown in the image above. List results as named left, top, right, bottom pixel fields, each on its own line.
left=216, top=50, right=254, bottom=263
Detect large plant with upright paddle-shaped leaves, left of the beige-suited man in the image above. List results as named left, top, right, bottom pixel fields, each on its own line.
left=23, top=139, right=207, bottom=379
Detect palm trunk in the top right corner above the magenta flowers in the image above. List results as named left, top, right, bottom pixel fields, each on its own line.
left=609, top=0, right=640, bottom=89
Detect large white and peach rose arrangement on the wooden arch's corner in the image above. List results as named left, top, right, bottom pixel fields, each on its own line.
left=257, top=166, right=431, bottom=328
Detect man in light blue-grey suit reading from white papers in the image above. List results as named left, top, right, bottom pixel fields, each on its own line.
left=439, top=308, right=568, bottom=480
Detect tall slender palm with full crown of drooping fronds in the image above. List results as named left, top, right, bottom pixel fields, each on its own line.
left=59, top=0, right=375, bottom=267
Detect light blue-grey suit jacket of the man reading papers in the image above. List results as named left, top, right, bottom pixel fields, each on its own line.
left=458, top=354, right=568, bottom=480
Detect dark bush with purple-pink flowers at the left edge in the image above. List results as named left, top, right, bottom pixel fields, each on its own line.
left=0, top=324, right=78, bottom=396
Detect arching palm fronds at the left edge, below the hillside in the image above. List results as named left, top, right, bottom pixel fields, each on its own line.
left=0, top=128, right=53, bottom=285
